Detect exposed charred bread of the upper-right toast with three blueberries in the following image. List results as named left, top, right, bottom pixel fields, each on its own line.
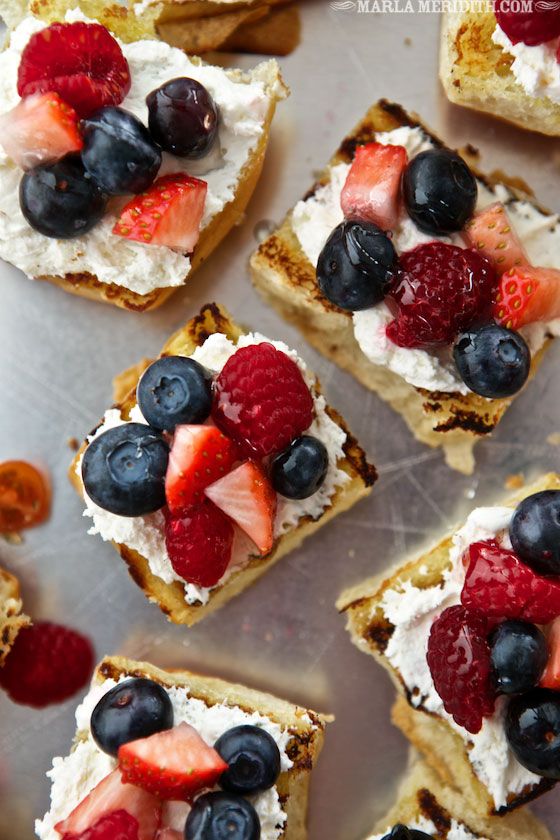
left=251, top=100, right=546, bottom=474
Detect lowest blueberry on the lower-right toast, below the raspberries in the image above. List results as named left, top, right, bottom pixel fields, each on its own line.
left=505, top=688, right=560, bottom=779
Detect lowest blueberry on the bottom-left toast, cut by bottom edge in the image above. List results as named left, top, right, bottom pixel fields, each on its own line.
left=185, top=793, right=261, bottom=840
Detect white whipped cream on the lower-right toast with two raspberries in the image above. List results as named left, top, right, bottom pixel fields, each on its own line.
left=381, top=507, right=541, bottom=808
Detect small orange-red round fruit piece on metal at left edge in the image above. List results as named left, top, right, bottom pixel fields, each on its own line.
left=0, top=461, right=51, bottom=534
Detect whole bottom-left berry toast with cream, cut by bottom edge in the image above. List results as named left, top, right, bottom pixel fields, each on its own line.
left=36, top=657, right=332, bottom=840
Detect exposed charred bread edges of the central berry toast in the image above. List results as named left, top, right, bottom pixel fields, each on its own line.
left=70, top=304, right=376, bottom=625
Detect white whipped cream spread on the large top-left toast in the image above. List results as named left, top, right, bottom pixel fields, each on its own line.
left=0, top=10, right=281, bottom=294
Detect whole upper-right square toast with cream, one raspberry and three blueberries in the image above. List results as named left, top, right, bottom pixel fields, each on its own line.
left=251, top=100, right=560, bottom=473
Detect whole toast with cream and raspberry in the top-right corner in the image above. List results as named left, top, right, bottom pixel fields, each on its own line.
left=439, top=7, right=560, bottom=137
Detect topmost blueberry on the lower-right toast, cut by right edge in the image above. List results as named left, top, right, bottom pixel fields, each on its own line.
left=509, top=490, right=560, bottom=575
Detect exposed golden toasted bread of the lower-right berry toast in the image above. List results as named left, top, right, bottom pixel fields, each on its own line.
left=337, top=473, right=560, bottom=816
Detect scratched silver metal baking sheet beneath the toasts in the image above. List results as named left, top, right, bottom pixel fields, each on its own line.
left=0, top=0, right=560, bottom=840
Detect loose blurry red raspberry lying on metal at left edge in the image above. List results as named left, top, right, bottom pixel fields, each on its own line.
left=0, top=621, right=94, bottom=709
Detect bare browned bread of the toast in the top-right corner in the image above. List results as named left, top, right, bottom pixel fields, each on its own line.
left=439, top=9, right=560, bottom=137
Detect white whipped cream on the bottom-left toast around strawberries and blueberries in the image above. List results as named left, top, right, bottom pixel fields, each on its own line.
left=35, top=677, right=292, bottom=840
